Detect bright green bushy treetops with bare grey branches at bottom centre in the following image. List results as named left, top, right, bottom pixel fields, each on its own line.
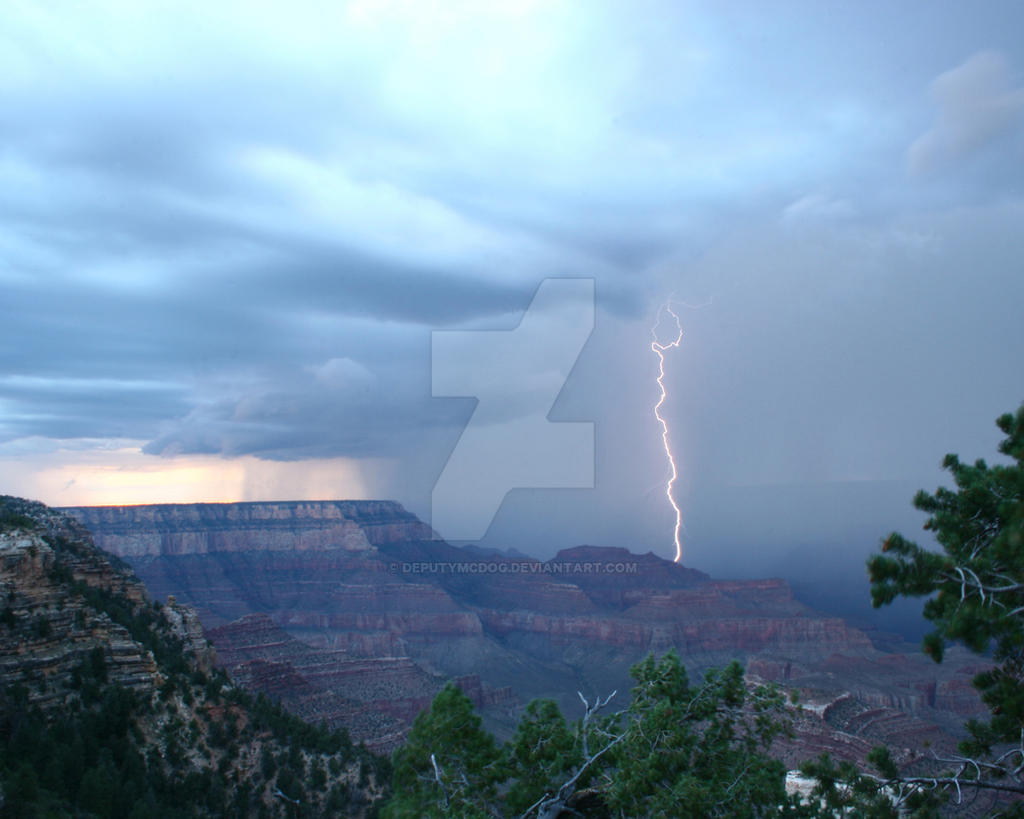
left=382, top=652, right=816, bottom=819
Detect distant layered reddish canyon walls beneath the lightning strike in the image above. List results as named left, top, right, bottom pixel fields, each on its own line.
left=65, top=501, right=983, bottom=764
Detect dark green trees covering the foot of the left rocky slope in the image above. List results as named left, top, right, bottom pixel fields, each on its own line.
left=0, top=634, right=390, bottom=819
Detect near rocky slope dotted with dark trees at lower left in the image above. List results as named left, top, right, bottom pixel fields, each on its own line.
left=0, top=497, right=382, bottom=817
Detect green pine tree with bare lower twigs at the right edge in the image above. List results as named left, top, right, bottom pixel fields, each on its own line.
left=868, top=404, right=1024, bottom=816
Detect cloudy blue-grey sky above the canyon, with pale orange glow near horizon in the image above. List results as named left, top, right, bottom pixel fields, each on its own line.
left=0, top=0, right=1024, bottom=589
